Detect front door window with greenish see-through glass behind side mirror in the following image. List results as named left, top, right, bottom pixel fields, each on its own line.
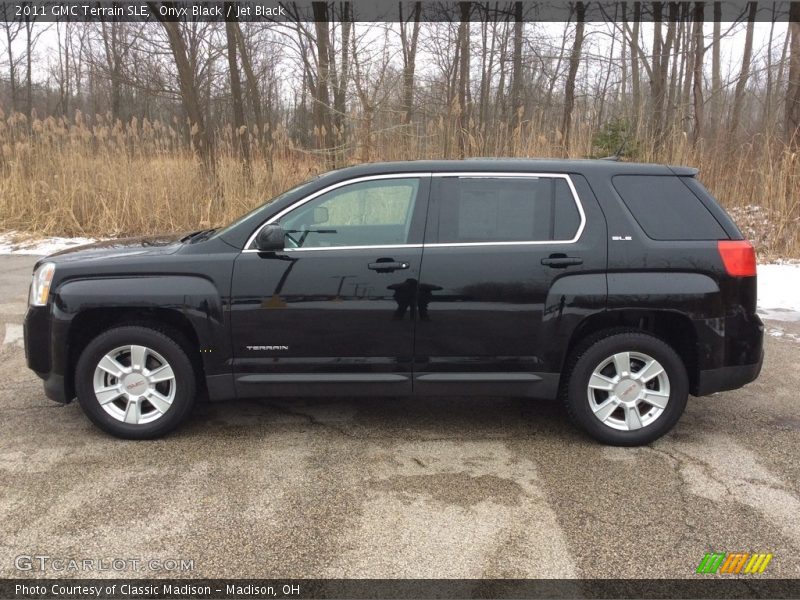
left=278, top=178, right=419, bottom=248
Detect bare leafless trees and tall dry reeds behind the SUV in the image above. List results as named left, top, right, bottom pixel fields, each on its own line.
left=0, top=2, right=800, bottom=256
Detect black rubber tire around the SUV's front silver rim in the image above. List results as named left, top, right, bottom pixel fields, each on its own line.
left=75, top=325, right=197, bottom=440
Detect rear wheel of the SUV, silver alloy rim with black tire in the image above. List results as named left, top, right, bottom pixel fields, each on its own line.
left=564, top=331, right=689, bottom=446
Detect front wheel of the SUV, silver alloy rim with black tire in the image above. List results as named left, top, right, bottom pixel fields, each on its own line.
left=75, top=326, right=196, bottom=439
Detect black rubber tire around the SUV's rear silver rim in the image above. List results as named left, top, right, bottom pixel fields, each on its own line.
left=562, top=330, right=689, bottom=446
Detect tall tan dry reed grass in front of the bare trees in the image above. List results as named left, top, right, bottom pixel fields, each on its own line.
left=0, top=113, right=800, bottom=258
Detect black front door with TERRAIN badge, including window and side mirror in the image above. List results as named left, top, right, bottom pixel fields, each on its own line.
left=231, top=175, right=429, bottom=397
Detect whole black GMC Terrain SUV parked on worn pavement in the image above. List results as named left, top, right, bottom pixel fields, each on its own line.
left=25, top=160, right=763, bottom=445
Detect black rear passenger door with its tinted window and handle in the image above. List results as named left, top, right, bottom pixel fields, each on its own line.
left=414, top=173, right=606, bottom=396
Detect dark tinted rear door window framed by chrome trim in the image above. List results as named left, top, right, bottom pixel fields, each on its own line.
left=438, top=177, right=580, bottom=243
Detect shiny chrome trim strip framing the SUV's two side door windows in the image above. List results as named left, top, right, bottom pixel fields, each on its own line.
left=242, top=171, right=586, bottom=252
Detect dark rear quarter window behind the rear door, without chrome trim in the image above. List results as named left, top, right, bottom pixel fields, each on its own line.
left=613, top=175, right=728, bottom=240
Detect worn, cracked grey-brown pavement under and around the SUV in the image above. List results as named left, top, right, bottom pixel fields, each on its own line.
left=0, top=256, right=800, bottom=578
